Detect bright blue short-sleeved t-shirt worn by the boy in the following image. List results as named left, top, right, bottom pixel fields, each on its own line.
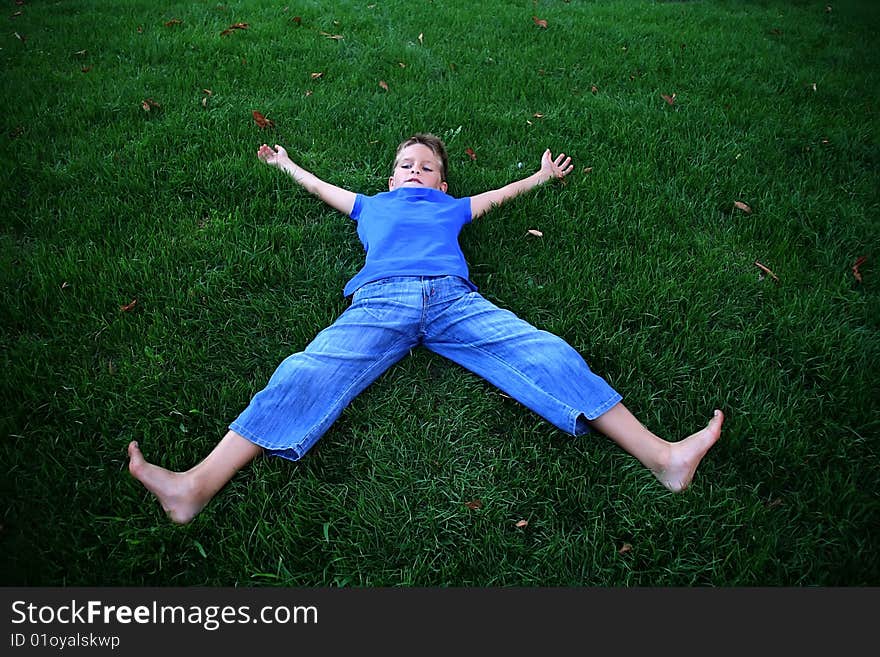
left=343, top=187, right=477, bottom=296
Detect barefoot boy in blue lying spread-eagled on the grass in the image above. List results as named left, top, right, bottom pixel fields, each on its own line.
left=128, top=134, right=724, bottom=523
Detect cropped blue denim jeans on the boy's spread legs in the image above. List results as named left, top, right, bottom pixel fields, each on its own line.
left=229, top=276, right=621, bottom=460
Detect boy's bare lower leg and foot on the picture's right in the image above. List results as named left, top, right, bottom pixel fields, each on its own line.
left=590, top=404, right=724, bottom=493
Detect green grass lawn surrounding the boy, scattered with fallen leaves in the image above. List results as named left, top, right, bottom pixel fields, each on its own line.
left=0, top=0, right=880, bottom=586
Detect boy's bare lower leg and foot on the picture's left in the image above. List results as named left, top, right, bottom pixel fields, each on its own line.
left=128, top=431, right=263, bottom=525
